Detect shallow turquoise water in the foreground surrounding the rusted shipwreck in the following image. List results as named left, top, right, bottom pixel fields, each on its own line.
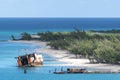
left=0, top=42, right=120, bottom=80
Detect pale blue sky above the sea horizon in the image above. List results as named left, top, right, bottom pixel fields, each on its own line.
left=0, top=0, right=120, bottom=17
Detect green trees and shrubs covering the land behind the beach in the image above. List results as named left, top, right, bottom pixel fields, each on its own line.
left=17, top=29, right=120, bottom=64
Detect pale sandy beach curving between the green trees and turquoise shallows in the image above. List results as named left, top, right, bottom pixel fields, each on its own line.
left=14, top=41, right=120, bottom=71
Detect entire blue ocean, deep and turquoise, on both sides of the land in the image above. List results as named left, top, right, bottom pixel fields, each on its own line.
left=0, top=18, right=120, bottom=80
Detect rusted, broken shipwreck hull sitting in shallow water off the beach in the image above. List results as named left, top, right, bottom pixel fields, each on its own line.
left=16, top=53, right=43, bottom=67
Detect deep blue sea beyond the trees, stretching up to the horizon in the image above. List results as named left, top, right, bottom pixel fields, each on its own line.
left=0, top=18, right=120, bottom=40
